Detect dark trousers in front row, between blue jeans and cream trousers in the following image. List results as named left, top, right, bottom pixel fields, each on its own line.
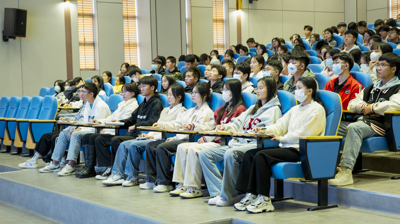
left=152, top=141, right=187, bottom=185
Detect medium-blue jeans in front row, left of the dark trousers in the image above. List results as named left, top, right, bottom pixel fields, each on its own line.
left=111, top=139, right=153, bottom=179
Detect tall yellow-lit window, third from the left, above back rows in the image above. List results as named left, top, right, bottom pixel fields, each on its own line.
left=213, top=0, right=225, bottom=54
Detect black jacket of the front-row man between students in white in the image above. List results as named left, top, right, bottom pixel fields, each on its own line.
left=121, top=93, right=163, bottom=137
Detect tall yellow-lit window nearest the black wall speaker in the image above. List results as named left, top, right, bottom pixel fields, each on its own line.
left=77, top=0, right=96, bottom=70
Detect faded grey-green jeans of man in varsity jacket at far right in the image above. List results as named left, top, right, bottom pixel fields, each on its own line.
left=339, top=118, right=378, bottom=169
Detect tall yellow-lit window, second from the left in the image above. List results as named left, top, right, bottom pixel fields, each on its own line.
left=122, top=0, right=139, bottom=65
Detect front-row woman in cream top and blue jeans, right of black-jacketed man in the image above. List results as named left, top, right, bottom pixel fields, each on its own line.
left=103, top=83, right=186, bottom=186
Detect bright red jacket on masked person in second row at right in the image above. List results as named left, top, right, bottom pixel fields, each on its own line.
left=324, top=75, right=363, bottom=110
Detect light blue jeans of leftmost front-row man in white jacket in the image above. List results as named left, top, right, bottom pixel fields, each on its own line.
left=51, top=130, right=92, bottom=162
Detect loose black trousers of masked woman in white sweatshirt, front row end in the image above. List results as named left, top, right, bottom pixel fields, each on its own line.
left=236, top=148, right=300, bottom=196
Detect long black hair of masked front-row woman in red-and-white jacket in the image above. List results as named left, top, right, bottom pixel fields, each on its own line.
left=217, top=79, right=246, bottom=124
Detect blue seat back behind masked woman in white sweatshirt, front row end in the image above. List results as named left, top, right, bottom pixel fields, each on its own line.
left=317, top=90, right=342, bottom=136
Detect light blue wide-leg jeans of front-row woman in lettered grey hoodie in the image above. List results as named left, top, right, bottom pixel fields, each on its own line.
left=199, top=144, right=257, bottom=200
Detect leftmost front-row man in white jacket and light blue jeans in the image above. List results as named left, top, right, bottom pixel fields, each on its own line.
left=39, top=83, right=111, bottom=176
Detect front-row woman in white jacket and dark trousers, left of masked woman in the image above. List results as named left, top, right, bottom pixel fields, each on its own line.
left=146, top=82, right=215, bottom=193
